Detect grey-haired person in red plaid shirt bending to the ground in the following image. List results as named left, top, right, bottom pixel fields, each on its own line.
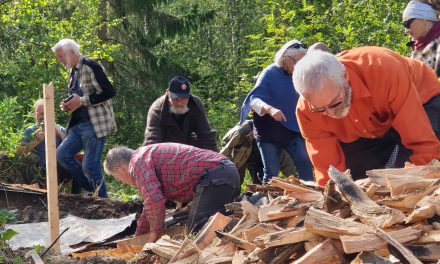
left=104, top=143, right=240, bottom=242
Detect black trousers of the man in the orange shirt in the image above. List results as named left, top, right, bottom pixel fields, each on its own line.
left=340, top=95, right=440, bottom=180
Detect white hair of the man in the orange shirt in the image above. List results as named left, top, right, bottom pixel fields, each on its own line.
left=292, top=50, right=345, bottom=96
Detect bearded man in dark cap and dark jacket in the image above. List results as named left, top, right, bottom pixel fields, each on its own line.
left=143, top=76, right=217, bottom=151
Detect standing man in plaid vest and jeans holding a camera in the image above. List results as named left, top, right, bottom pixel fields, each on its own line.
left=52, top=39, right=116, bottom=197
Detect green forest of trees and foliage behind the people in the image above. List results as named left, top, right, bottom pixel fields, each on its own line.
left=0, top=0, right=410, bottom=199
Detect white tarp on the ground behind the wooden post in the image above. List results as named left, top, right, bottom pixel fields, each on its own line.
left=6, top=214, right=135, bottom=254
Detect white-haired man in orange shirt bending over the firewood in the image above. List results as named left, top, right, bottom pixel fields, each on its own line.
left=293, top=47, right=440, bottom=185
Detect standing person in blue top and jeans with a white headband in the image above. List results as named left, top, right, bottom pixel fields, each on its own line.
left=240, top=40, right=314, bottom=183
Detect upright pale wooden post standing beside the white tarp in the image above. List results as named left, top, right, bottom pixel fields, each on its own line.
left=43, top=82, right=60, bottom=252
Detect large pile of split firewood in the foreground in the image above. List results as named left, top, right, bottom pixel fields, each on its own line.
left=138, top=161, right=440, bottom=264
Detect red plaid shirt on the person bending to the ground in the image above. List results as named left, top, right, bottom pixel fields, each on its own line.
left=129, top=143, right=226, bottom=235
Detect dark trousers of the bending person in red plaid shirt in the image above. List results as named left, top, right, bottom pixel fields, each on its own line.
left=187, top=160, right=240, bottom=233
